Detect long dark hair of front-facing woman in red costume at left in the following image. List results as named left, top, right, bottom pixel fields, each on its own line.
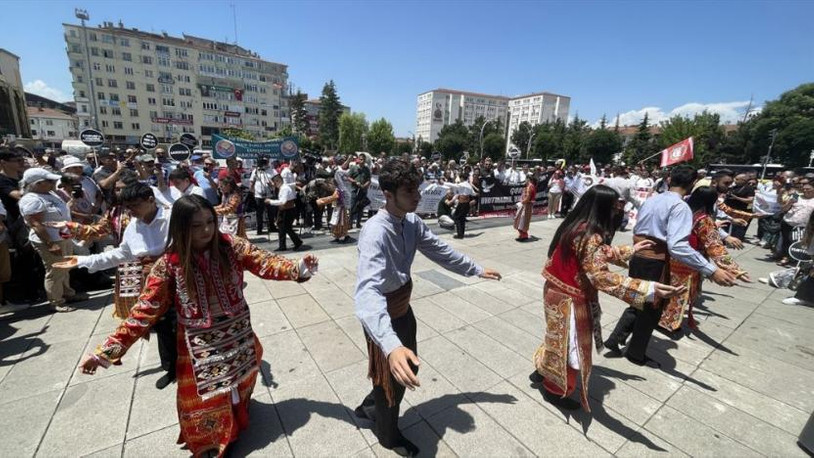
left=165, top=194, right=230, bottom=294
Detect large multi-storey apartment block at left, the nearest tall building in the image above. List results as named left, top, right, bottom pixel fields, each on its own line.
left=63, top=22, right=290, bottom=146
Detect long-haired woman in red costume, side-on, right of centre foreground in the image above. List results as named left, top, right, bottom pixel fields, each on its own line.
left=529, top=185, right=686, bottom=412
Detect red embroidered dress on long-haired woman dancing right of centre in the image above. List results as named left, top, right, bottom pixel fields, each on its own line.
left=534, top=234, right=650, bottom=412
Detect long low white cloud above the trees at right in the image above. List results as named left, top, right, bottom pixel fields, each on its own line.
left=592, top=101, right=761, bottom=127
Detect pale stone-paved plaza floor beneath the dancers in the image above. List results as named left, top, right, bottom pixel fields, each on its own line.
left=0, top=219, right=814, bottom=457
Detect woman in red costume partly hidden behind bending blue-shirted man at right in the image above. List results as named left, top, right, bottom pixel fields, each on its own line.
left=659, top=186, right=750, bottom=331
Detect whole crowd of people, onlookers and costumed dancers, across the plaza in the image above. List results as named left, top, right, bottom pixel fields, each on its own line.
left=0, top=141, right=814, bottom=456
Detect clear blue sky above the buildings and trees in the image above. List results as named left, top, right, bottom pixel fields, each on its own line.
left=0, top=0, right=814, bottom=136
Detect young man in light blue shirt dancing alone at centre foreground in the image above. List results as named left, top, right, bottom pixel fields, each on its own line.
left=354, top=159, right=501, bottom=456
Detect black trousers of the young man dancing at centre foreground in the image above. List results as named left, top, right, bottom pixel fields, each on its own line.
left=361, top=307, right=418, bottom=448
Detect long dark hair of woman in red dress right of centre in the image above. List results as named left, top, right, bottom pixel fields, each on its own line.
left=548, top=184, right=619, bottom=258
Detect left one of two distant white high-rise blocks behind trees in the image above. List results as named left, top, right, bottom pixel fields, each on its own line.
left=415, top=89, right=509, bottom=143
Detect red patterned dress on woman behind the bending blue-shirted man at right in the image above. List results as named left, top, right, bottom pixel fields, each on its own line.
left=659, top=212, right=746, bottom=331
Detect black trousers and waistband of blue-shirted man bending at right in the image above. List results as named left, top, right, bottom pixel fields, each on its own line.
left=608, top=256, right=667, bottom=361
